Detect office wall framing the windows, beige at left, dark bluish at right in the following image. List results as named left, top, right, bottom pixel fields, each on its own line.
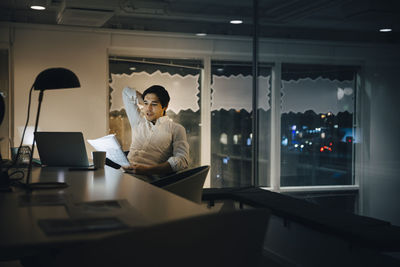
left=0, top=24, right=400, bottom=225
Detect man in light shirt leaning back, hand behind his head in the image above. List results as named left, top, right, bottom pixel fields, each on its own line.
left=122, top=85, right=189, bottom=175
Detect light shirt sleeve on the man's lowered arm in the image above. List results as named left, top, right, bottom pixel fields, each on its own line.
left=168, top=125, right=189, bottom=172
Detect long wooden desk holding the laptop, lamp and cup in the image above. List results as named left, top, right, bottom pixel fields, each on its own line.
left=0, top=166, right=209, bottom=260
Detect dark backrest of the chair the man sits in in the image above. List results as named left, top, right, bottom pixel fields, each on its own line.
left=152, top=166, right=210, bottom=203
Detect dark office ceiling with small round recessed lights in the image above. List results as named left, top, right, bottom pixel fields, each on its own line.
left=0, top=0, right=400, bottom=44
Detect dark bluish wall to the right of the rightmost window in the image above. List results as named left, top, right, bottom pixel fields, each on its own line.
left=361, top=64, right=400, bottom=226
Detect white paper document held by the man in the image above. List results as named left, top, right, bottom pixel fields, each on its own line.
left=87, top=134, right=129, bottom=166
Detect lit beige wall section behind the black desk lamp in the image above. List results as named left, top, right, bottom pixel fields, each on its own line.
left=12, top=28, right=110, bottom=156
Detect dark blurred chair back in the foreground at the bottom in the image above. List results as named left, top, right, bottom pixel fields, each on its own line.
left=48, top=209, right=270, bottom=267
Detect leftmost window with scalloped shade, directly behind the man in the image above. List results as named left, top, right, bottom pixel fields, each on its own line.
left=109, top=57, right=202, bottom=167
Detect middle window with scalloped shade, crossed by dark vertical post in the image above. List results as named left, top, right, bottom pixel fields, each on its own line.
left=211, top=61, right=270, bottom=187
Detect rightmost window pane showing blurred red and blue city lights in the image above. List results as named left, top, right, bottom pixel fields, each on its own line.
left=281, top=64, right=357, bottom=186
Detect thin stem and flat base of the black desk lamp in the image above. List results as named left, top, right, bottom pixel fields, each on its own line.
left=26, top=90, right=68, bottom=190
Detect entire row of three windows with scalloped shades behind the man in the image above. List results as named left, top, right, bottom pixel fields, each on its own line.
left=109, top=57, right=359, bottom=189
